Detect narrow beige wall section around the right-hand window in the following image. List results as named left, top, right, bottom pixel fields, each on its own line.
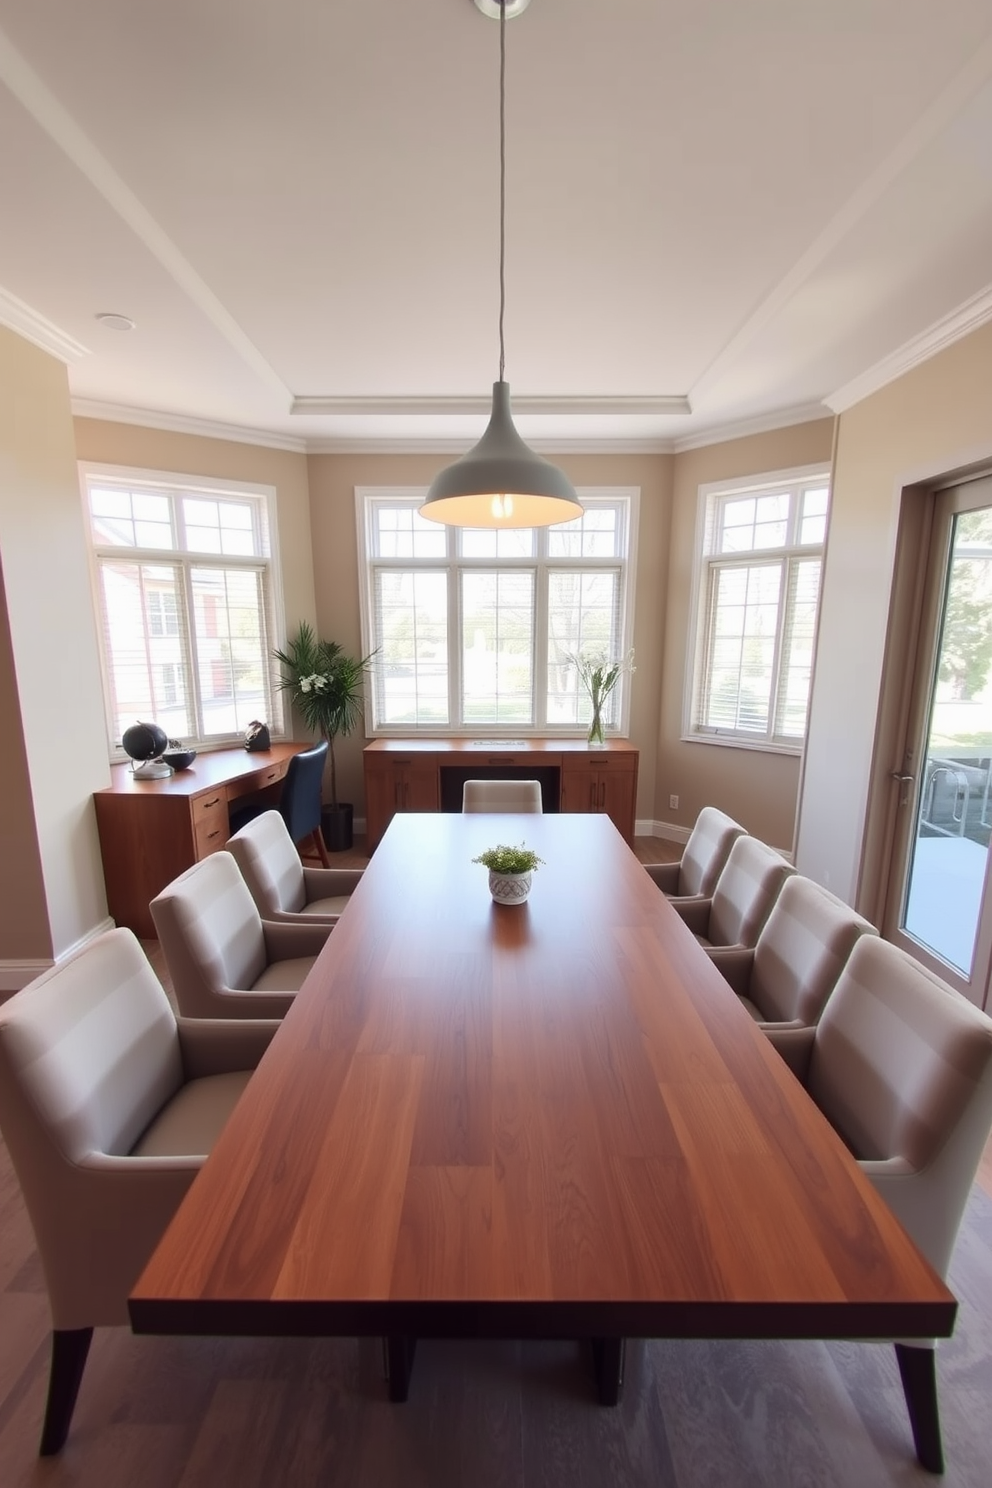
left=660, top=418, right=833, bottom=850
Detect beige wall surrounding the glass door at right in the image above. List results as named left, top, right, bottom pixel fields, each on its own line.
left=797, top=326, right=992, bottom=903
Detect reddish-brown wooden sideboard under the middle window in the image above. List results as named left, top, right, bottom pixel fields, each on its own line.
left=364, top=738, right=640, bottom=853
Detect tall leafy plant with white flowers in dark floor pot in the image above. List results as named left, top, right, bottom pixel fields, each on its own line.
left=272, top=620, right=375, bottom=853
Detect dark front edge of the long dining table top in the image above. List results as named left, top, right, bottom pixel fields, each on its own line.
left=128, top=1298, right=958, bottom=1342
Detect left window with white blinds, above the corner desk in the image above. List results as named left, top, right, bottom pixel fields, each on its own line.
left=82, top=467, right=281, bottom=751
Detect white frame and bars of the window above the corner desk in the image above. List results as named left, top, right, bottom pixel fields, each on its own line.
left=77, top=460, right=286, bottom=762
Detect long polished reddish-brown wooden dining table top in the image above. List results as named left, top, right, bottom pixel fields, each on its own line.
left=131, top=814, right=955, bottom=1338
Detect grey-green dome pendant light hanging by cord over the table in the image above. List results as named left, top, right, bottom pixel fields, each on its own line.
left=419, top=0, right=582, bottom=527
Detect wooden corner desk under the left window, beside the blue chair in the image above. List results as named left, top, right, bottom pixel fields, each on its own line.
left=94, top=743, right=309, bottom=940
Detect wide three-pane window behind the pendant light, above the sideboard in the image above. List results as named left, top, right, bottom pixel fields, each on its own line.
left=357, top=490, right=637, bottom=735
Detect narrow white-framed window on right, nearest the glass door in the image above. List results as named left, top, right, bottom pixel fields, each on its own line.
left=686, top=470, right=830, bottom=750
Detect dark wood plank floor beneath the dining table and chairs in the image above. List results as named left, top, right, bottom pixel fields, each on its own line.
left=0, top=841, right=992, bottom=1488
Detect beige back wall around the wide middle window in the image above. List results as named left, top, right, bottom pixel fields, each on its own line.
left=309, top=455, right=672, bottom=818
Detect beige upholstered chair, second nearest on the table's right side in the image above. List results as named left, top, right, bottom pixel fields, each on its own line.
left=709, top=873, right=876, bottom=1030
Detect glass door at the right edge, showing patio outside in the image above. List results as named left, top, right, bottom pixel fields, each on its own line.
left=883, top=479, right=992, bottom=1007
